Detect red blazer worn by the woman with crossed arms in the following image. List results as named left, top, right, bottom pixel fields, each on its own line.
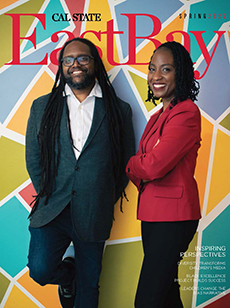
left=126, top=99, right=201, bottom=221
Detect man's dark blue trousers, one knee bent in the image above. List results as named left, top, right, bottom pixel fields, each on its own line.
left=28, top=205, right=105, bottom=308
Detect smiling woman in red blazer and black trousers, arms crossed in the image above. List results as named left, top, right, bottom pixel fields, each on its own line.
left=126, top=42, right=201, bottom=308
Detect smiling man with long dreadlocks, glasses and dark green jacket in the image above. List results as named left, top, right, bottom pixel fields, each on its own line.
left=26, top=38, right=135, bottom=308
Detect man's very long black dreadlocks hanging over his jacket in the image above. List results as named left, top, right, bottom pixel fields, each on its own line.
left=30, top=37, right=124, bottom=215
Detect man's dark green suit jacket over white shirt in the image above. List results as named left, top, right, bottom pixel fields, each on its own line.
left=26, top=95, right=135, bottom=242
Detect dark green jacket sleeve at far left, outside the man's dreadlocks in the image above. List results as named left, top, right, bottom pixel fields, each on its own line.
left=26, top=101, right=41, bottom=193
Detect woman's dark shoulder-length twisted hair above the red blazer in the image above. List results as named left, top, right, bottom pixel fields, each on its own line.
left=146, top=41, right=200, bottom=105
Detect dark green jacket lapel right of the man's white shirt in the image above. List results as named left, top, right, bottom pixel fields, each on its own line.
left=81, top=98, right=105, bottom=153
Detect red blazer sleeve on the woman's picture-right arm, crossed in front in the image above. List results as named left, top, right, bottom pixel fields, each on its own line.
left=126, top=105, right=201, bottom=184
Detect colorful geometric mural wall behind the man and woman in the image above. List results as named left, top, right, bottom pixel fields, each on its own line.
left=0, top=0, right=230, bottom=308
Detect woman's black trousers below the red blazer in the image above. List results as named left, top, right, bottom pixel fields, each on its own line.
left=135, top=220, right=198, bottom=308
